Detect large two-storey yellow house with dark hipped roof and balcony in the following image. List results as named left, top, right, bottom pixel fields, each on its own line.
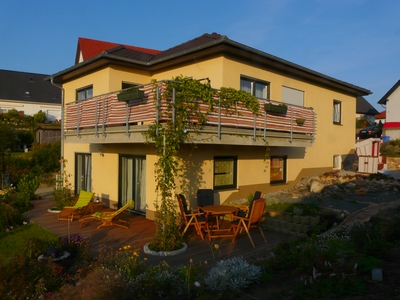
left=48, top=33, right=371, bottom=219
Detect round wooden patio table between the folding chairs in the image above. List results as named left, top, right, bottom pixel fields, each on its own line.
left=200, top=205, right=238, bottom=241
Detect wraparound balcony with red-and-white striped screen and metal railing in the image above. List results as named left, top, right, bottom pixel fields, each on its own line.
left=65, top=82, right=316, bottom=147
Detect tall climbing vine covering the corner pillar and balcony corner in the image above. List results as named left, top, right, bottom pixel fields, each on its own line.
left=143, top=76, right=259, bottom=251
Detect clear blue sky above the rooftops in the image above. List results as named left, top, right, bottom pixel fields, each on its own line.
left=0, top=0, right=400, bottom=111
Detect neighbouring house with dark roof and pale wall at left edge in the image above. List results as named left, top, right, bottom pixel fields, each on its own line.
left=0, top=70, right=61, bottom=121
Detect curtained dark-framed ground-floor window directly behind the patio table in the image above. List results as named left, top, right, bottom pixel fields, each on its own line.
left=214, top=156, right=237, bottom=190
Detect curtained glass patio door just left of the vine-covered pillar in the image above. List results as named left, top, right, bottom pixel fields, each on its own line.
left=118, top=155, right=146, bottom=214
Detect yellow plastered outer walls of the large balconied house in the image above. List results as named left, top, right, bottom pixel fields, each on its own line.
left=64, top=57, right=356, bottom=219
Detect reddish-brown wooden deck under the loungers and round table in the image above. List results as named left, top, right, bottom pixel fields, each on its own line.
left=25, top=193, right=294, bottom=267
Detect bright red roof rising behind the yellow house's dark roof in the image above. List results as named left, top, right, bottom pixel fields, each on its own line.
left=75, top=38, right=161, bottom=64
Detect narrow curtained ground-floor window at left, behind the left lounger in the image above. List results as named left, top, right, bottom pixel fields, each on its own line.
left=75, top=153, right=92, bottom=195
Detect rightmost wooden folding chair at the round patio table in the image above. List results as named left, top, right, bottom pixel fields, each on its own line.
left=231, top=199, right=267, bottom=248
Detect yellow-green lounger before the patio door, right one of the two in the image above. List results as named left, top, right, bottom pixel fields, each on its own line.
left=79, top=200, right=134, bottom=229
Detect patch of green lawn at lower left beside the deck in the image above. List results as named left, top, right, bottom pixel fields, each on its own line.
left=0, top=223, right=60, bottom=262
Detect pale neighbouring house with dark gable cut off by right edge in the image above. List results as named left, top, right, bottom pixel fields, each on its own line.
left=378, top=80, right=400, bottom=140
